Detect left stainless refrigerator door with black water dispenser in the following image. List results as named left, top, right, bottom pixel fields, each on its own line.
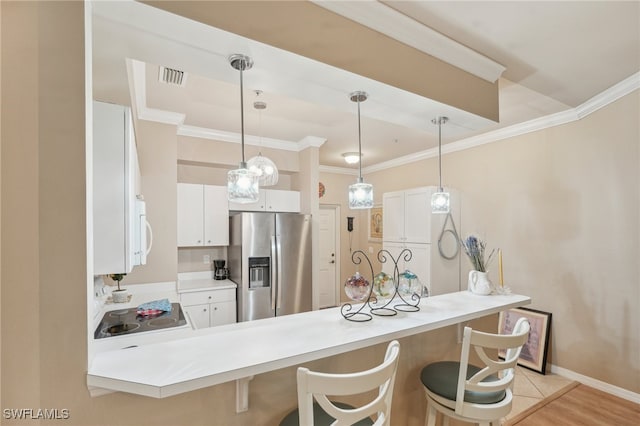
left=228, top=213, right=276, bottom=321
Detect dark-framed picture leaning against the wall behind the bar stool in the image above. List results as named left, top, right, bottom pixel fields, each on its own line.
left=498, top=308, right=551, bottom=374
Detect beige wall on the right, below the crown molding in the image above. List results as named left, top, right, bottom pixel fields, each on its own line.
left=368, top=91, right=640, bottom=392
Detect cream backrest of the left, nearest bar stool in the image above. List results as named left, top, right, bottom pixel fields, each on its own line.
left=298, top=340, right=400, bottom=426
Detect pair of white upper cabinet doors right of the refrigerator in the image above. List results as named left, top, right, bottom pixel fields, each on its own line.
left=382, top=187, right=433, bottom=244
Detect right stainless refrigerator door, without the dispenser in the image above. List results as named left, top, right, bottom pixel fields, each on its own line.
left=275, top=213, right=312, bottom=316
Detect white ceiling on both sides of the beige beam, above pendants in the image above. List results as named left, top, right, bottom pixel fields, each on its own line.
left=93, top=1, right=640, bottom=171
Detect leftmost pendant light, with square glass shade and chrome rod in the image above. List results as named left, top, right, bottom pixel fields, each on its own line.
left=227, top=54, right=260, bottom=203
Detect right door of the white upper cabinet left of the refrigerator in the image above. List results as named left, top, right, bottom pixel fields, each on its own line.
left=204, top=185, right=229, bottom=246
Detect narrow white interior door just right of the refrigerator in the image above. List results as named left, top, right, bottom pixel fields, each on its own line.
left=318, top=206, right=340, bottom=308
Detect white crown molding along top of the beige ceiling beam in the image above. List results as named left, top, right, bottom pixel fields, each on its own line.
left=311, top=0, right=506, bottom=83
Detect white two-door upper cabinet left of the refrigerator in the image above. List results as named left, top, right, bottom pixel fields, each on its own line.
left=178, top=183, right=229, bottom=247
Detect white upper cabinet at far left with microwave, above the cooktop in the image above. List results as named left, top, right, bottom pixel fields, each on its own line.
left=93, top=102, right=146, bottom=275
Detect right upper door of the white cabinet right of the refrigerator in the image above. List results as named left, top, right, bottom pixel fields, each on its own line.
left=404, top=188, right=431, bottom=244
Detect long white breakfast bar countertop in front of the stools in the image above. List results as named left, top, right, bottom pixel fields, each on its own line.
left=87, top=291, right=531, bottom=398
